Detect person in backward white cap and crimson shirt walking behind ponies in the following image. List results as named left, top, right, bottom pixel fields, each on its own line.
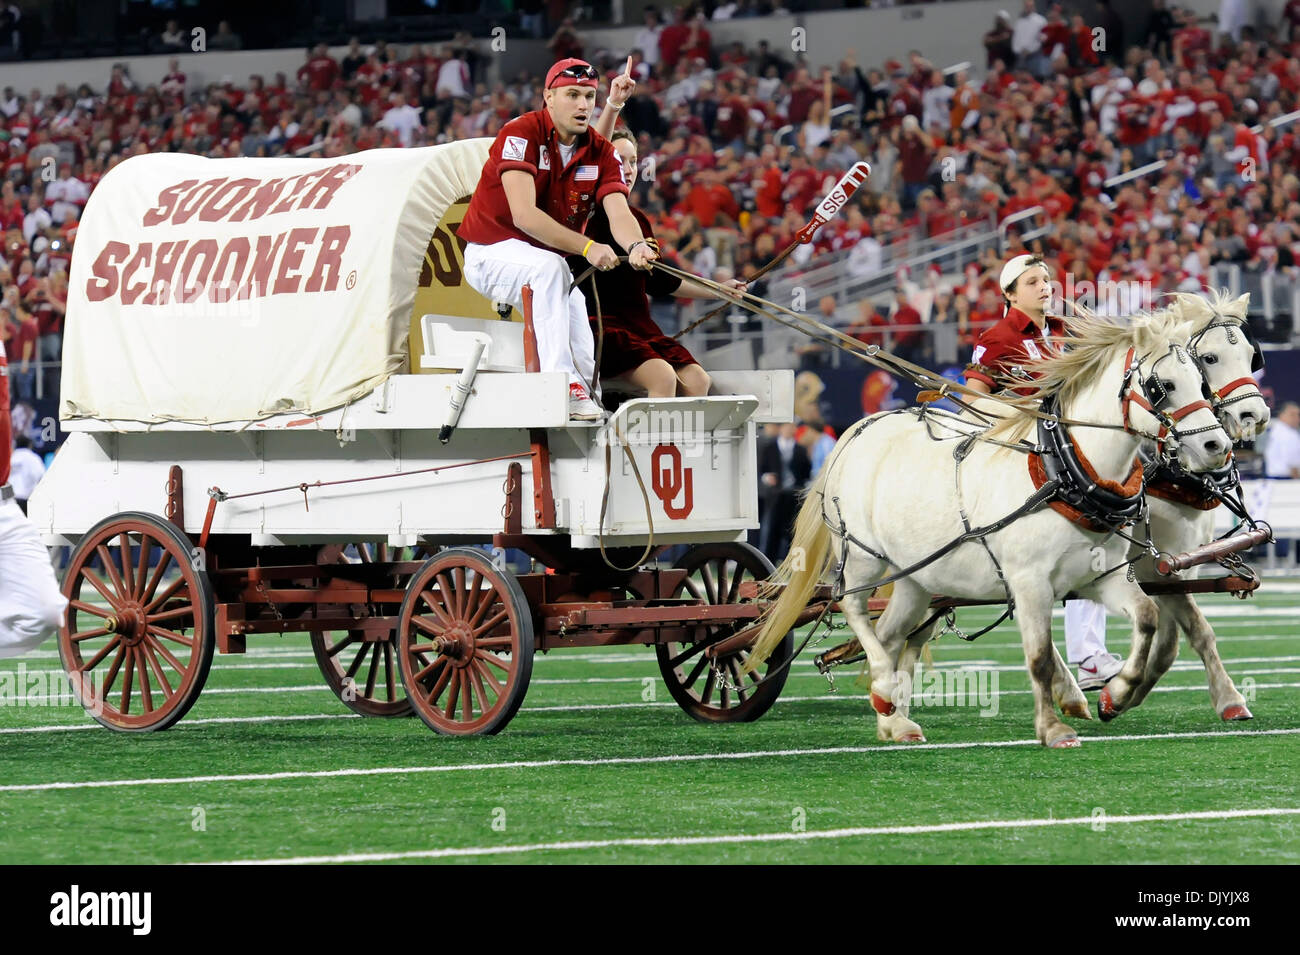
left=966, top=253, right=1123, bottom=690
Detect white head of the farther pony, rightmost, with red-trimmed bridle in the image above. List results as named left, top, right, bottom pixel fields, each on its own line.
left=1167, top=290, right=1269, bottom=440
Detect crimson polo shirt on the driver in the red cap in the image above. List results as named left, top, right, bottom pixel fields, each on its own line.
left=456, top=109, right=628, bottom=252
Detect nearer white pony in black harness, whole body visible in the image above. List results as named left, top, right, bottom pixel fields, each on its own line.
left=749, top=311, right=1231, bottom=748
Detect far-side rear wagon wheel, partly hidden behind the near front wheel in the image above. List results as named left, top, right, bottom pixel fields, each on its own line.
left=311, top=543, right=429, bottom=717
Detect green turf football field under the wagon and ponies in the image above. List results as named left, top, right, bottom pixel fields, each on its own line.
left=0, top=579, right=1300, bottom=864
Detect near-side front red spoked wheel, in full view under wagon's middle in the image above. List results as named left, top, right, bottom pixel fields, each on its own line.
left=398, top=547, right=533, bottom=735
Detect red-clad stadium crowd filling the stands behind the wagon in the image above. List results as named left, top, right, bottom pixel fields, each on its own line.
left=0, top=0, right=1300, bottom=470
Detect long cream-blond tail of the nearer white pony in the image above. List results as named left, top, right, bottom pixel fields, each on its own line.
left=749, top=440, right=846, bottom=668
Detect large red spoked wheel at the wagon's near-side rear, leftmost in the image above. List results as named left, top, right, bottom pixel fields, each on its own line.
left=59, top=512, right=215, bottom=733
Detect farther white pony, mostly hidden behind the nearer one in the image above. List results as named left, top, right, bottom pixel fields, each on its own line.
left=1097, top=291, right=1269, bottom=720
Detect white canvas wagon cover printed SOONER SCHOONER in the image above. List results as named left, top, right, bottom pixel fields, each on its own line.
left=60, top=139, right=490, bottom=424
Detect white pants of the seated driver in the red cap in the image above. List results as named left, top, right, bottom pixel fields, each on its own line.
left=465, top=239, right=595, bottom=386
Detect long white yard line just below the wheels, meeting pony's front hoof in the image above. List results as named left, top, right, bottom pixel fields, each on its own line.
left=0, top=727, right=1300, bottom=793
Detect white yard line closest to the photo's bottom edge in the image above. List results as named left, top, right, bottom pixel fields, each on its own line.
left=208, top=807, right=1300, bottom=865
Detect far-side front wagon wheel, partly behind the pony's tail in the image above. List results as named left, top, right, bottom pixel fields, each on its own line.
left=655, top=543, right=794, bottom=722
